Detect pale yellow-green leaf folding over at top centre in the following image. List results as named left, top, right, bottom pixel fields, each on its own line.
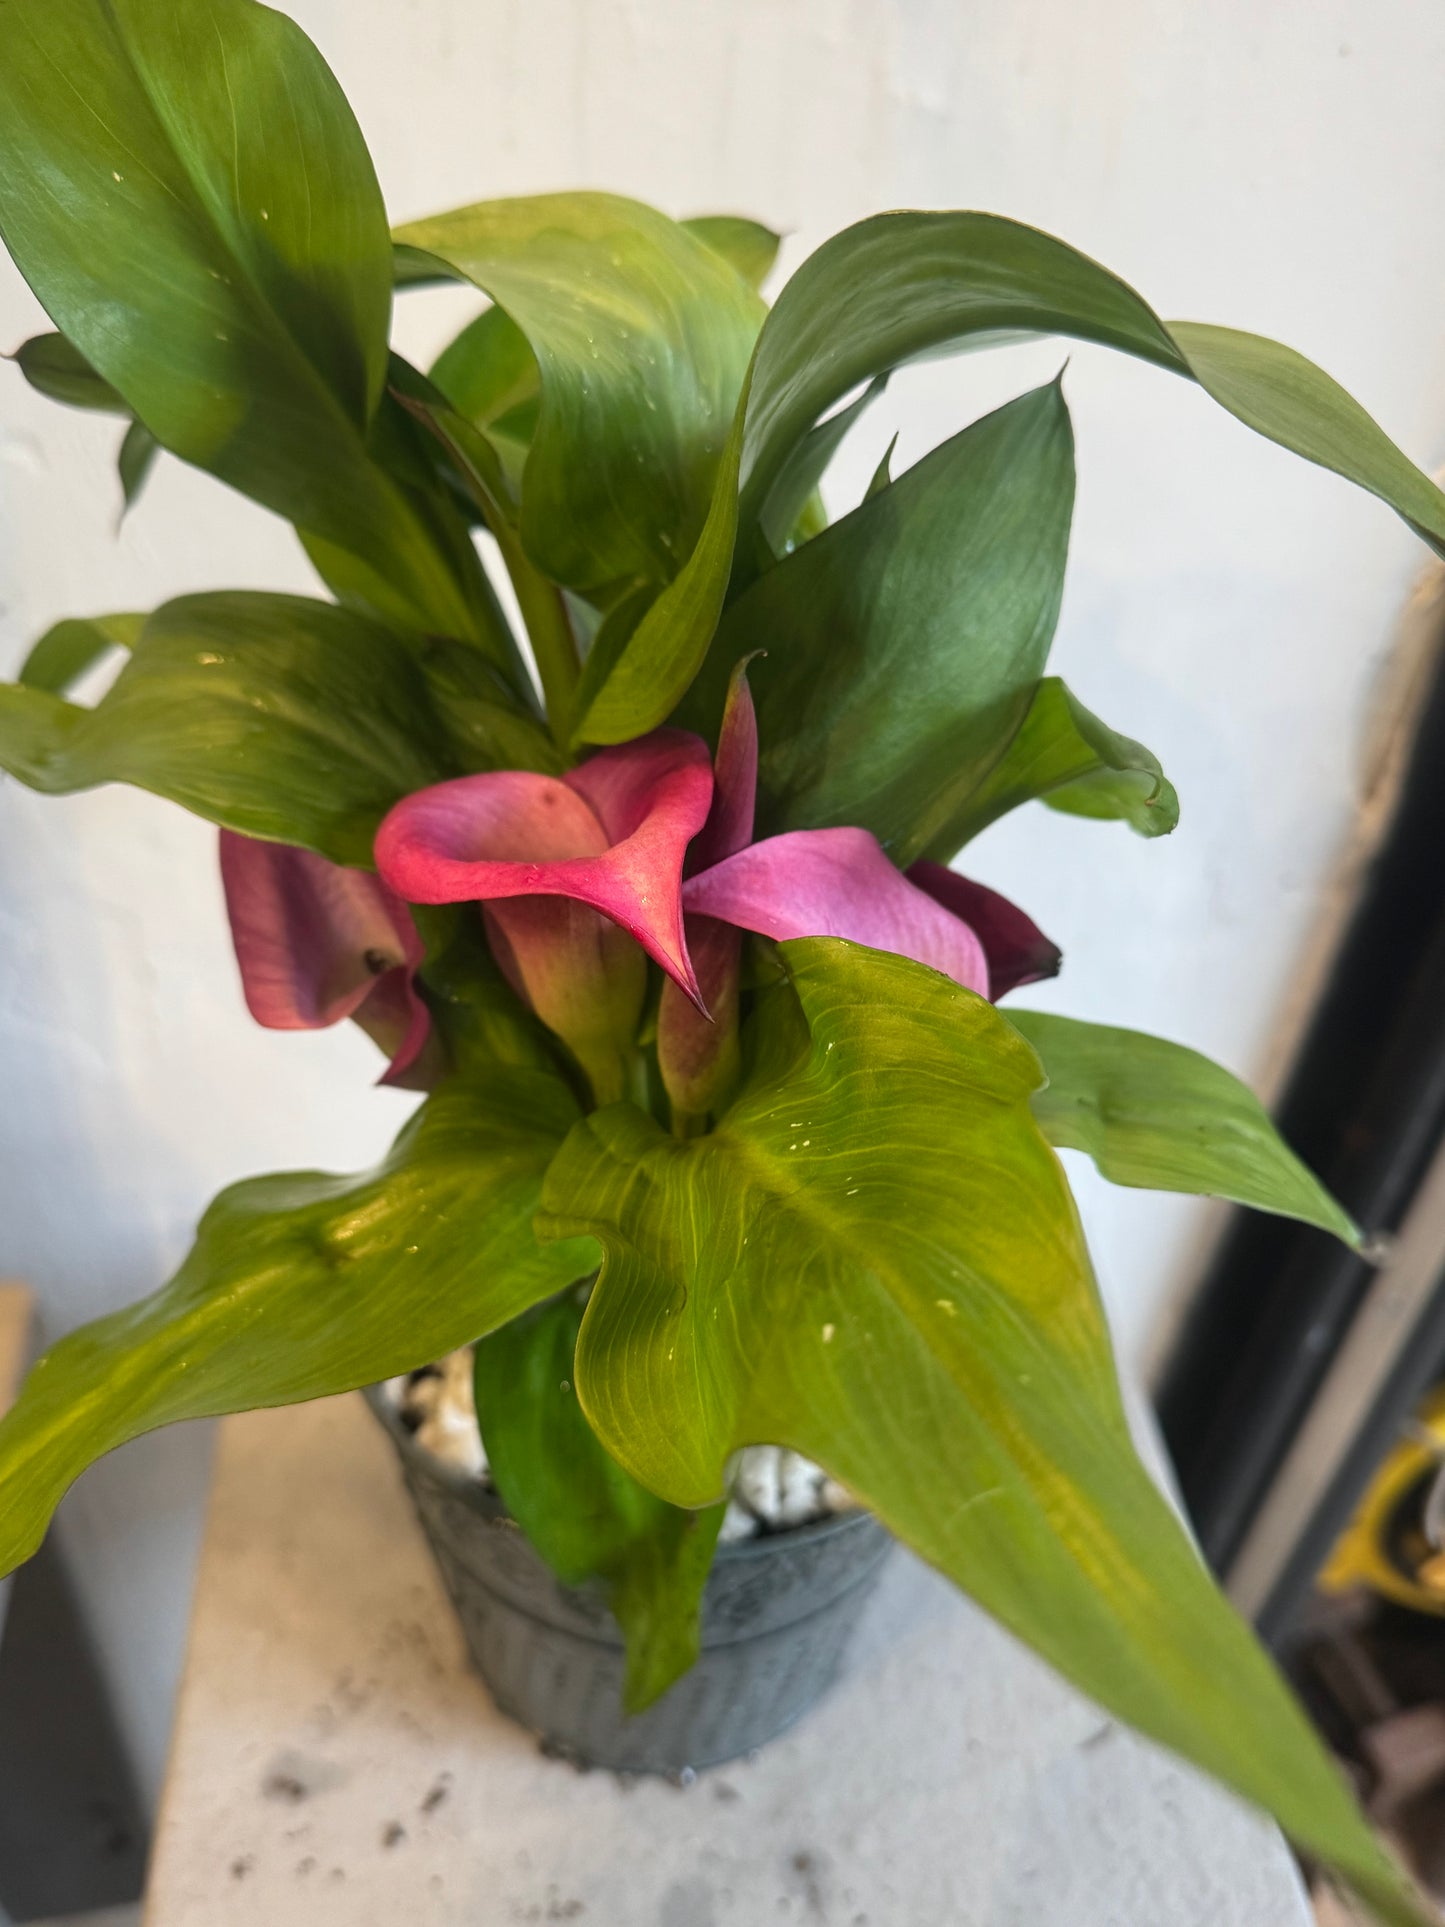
left=397, top=193, right=763, bottom=599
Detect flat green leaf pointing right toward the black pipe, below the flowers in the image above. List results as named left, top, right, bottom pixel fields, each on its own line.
left=1008, top=1010, right=1360, bottom=1245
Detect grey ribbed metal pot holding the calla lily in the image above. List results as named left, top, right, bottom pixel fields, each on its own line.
left=366, top=1389, right=892, bottom=1775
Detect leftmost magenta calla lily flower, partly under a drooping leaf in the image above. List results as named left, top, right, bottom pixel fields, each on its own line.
left=222, top=831, right=432, bottom=1089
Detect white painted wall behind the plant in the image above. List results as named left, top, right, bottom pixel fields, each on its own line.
left=0, top=0, right=1445, bottom=1784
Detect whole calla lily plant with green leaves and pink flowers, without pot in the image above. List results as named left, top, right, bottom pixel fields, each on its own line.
left=0, top=0, right=1445, bottom=1921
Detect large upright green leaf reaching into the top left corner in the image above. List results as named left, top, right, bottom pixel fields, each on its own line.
left=0, top=0, right=504, bottom=655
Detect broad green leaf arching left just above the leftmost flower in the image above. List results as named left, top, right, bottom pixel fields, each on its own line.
left=0, top=592, right=547, bottom=865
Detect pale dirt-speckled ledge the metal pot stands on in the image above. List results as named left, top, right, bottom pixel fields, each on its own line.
left=145, top=1399, right=1310, bottom=1927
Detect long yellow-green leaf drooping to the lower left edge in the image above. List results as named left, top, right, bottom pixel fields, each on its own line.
left=0, top=1066, right=593, bottom=1571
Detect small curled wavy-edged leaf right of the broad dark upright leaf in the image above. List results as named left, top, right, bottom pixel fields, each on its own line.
left=929, top=676, right=1179, bottom=861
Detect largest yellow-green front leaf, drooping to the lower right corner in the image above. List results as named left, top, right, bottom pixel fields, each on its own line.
left=539, top=938, right=1424, bottom=1923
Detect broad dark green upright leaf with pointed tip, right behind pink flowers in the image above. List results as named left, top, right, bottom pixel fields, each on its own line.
left=684, top=383, right=1073, bottom=865
